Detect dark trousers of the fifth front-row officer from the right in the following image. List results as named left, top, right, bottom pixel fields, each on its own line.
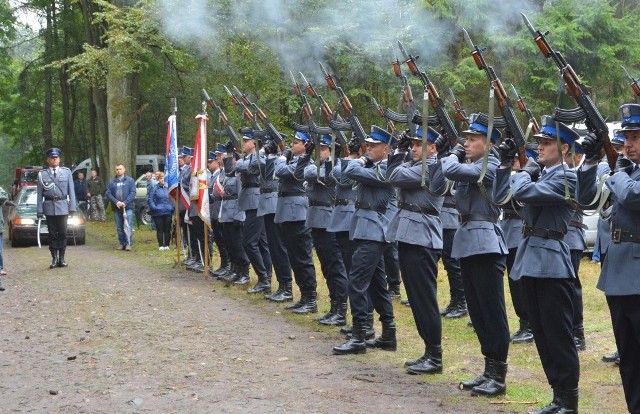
left=349, top=240, right=394, bottom=326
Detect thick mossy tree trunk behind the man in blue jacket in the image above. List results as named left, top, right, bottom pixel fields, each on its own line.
left=107, top=72, right=139, bottom=176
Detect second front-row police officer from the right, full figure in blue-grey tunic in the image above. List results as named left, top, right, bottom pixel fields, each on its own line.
left=496, top=116, right=580, bottom=414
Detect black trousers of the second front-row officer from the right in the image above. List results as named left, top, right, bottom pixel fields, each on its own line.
left=521, top=276, right=580, bottom=389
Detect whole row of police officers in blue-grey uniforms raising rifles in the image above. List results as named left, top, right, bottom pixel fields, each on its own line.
left=172, top=105, right=640, bottom=414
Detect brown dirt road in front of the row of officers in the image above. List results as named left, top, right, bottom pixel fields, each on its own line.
left=0, top=246, right=502, bottom=413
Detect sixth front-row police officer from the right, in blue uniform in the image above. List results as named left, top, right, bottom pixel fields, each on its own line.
left=296, top=135, right=349, bottom=326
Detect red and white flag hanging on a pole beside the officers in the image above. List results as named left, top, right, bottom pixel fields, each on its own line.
left=189, top=114, right=211, bottom=227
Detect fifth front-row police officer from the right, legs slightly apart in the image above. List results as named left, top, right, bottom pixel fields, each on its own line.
left=333, top=125, right=397, bottom=355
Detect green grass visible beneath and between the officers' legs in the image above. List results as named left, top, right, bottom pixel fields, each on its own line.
left=87, top=218, right=627, bottom=413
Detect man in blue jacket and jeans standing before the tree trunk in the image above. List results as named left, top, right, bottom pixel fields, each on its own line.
left=107, top=164, right=136, bottom=251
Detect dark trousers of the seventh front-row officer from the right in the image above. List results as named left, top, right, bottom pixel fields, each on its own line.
left=281, top=220, right=317, bottom=293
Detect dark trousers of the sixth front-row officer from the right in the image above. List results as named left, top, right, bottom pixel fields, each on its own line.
left=311, top=228, right=349, bottom=303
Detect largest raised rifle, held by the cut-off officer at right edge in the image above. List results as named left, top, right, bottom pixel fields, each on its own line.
left=520, top=13, right=618, bottom=170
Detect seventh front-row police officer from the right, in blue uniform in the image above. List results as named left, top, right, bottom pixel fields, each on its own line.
left=274, top=131, right=318, bottom=314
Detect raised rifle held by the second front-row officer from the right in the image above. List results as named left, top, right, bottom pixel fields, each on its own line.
left=462, top=29, right=527, bottom=165
